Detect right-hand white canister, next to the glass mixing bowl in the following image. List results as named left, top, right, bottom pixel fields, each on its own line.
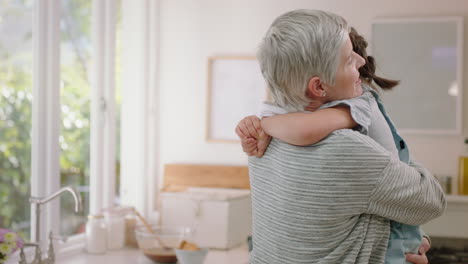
left=104, top=208, right=125, bottom=249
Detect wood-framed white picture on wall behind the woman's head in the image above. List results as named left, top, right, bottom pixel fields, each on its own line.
left=206, top=56, right=267, bottom=143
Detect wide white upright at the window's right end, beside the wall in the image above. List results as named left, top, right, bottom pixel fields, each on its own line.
left=120, top=0, right=161, bottom=218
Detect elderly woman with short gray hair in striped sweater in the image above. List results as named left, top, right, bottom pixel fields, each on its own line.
left=241, top=10, right=445, bottom=264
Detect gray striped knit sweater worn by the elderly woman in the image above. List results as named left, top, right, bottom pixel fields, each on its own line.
left=249, top=129, right=446, bottom=264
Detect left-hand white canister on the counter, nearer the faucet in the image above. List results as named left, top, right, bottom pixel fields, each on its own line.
left=86, top=214, right=107, bottom=254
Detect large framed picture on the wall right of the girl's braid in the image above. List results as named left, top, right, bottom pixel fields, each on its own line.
left=371, top=17, right=463, bottom=135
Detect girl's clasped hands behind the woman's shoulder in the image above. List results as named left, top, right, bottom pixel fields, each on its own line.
left=236, top=115, right=271, bottom=157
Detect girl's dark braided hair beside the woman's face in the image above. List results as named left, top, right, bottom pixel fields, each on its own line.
left=349, top=27, right=400, bottom=90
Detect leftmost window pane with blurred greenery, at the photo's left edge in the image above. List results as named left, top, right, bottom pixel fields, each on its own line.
left=0, top=0, right=33, bottom=239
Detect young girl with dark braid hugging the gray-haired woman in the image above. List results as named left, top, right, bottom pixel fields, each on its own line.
left=236, top=28, right=429, bottom=264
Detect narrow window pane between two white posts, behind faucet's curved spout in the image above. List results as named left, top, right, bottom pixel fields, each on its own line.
left=60, top=0, right=92, bottom=236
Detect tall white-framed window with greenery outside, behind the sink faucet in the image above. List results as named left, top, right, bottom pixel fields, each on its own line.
left=0, top=0, right=120, bottom=253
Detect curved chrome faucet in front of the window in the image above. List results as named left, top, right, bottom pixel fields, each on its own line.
left=19, top=186, right=83, bottom=264
